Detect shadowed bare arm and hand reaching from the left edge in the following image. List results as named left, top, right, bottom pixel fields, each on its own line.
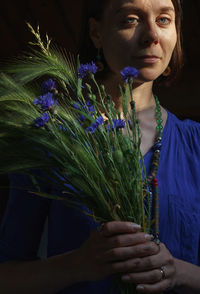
left=0, top=222, right=153, bottom=294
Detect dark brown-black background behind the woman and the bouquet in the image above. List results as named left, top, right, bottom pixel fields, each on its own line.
left=0, top=0, right=200, bottom=220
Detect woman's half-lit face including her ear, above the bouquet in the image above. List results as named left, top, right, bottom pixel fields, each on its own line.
left=90, top=0, right=177, bottom=82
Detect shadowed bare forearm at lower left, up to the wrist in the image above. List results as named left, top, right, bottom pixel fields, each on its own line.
left=0, top=251, right=81, bottom=294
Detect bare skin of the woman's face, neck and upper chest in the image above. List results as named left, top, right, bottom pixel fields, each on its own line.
left=90, top=0, right=177, bottom=155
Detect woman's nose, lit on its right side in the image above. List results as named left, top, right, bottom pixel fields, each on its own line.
left=140, top=24, right=159, bottom=47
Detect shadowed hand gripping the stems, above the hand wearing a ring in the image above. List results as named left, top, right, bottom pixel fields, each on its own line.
left=78, top=221, right=159, bottom=281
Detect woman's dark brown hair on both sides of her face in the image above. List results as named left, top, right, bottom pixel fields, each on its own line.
left=80, top=0, right=183, bottom=85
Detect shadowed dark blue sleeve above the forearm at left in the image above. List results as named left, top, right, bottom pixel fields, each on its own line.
left=0, top=175, right=50, bottom=262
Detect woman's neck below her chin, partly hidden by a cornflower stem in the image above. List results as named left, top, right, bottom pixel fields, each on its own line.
left=99, top=76, right=155, bottom=112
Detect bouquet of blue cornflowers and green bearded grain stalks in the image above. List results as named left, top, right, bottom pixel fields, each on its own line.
left=0, top=25, right=151, bottom=293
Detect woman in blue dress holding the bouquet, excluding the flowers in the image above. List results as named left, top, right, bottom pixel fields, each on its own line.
left=0, top=0, right=200, bottom=294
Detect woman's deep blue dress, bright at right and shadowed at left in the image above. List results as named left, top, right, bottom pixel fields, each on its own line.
left=0, top=112, right=200, bottom=294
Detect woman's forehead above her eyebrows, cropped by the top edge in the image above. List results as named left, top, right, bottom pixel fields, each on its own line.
left=106, top=0, right=174, bottom=12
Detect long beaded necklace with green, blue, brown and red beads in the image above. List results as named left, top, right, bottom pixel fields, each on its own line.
left=147, top=96, right=163, bottom=244
